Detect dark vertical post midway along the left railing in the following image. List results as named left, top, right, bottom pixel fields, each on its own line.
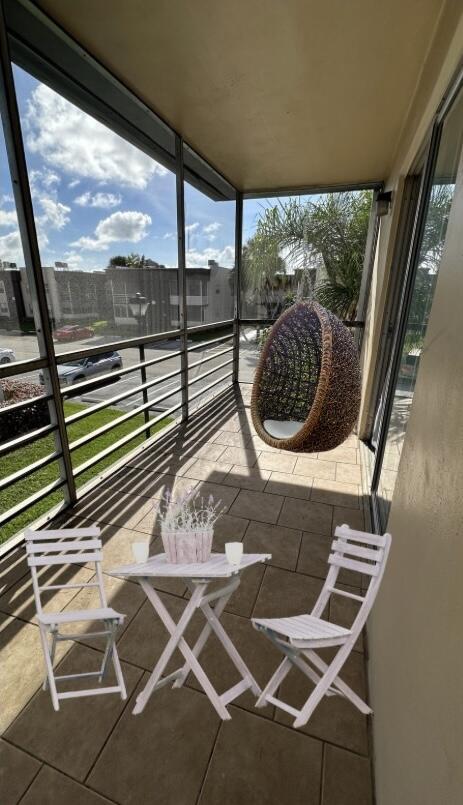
left=175, top=134, right=189, bottom=422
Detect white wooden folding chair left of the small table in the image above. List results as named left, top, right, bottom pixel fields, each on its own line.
left=25, top=526, right=127, bottom=710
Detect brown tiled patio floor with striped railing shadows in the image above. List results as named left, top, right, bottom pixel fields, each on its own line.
left=0, top=388, right=373, bottom=805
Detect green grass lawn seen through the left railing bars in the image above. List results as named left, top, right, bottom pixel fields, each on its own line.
left=0, top=402, right=172, bottom=543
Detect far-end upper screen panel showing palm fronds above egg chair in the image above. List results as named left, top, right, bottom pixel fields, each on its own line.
left=241, top=190, right=372, bottom=319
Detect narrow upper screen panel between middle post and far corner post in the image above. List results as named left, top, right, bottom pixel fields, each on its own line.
left=185, top=177, right=236, bottom=325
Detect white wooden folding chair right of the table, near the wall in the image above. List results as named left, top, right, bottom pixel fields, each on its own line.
left=252, top=525, right=391, bottom=728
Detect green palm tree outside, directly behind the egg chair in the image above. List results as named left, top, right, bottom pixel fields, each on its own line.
left=245, top=191, right=372, bottom=319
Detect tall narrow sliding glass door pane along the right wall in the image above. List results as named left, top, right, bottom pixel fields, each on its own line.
left=376, top=88, right=463, bottom=530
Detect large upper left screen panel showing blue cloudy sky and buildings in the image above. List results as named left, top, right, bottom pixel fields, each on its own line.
left=12, top=62, right=178, bottom=352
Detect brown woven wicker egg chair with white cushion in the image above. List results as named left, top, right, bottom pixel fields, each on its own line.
left=251, top=302, right=360, bottom=453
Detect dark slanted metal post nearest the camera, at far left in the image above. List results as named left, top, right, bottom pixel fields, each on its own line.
left=0, top=6, right=76, bottom=503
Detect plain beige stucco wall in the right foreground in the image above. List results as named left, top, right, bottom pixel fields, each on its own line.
left=369, top=148, right=463, bottom=805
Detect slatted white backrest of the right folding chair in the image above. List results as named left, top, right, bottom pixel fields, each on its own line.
left=312, top=525, right=391, bottom=636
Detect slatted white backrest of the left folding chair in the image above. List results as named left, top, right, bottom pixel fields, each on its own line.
left=25, top=526, right=106, bottom=614
